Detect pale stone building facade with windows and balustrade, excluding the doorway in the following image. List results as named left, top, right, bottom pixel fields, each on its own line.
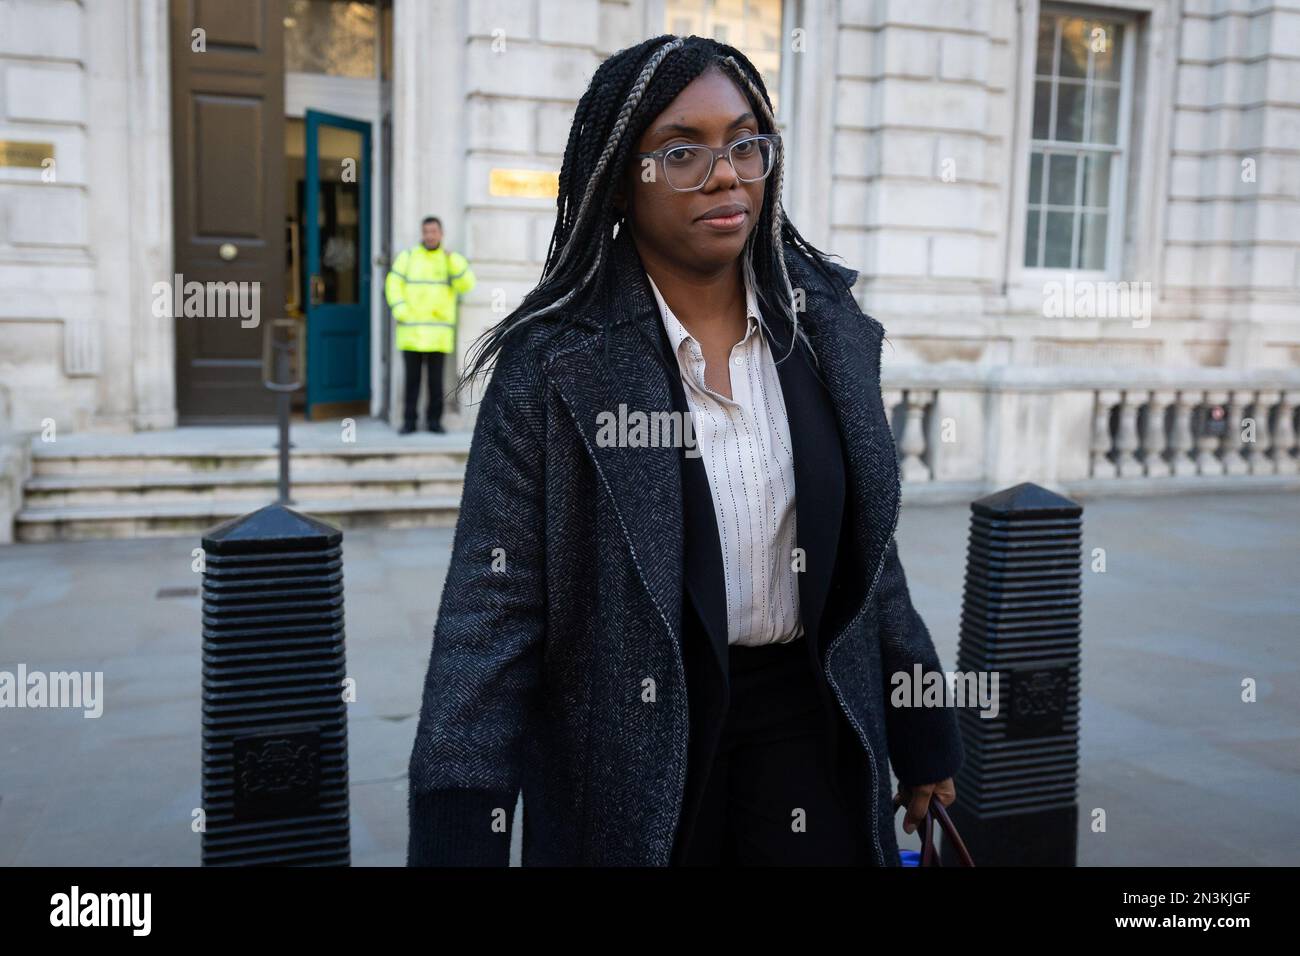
left=0, top=0, right=1300, bottom=486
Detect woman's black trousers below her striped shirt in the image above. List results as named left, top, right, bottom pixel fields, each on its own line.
left=680, top=637, right=874, bottom=866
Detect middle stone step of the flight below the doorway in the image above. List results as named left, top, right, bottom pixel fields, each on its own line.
left=23, top=459, right=464, bottom=509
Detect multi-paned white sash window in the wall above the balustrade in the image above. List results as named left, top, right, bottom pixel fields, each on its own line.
left=1024, top=8, right=1132, bottom=272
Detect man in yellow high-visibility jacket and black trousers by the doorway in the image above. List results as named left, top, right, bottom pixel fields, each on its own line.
left=384, top=216, right=475, bottom=434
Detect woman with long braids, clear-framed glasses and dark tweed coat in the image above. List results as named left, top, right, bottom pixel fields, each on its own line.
left=408, top=35, right=962, bottom=865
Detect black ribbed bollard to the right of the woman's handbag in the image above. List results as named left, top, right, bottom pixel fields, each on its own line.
left=943, top=484, right=1083, bottom=866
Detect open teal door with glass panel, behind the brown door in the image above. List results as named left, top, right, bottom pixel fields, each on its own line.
left=303, top=111, right=371, bottom=419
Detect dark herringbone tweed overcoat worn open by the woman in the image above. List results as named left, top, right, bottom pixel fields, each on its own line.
left=408, top=230, right=962, bottom=866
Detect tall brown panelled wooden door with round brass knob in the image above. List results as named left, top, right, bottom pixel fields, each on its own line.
left=168, top=0, right=285, bottom=424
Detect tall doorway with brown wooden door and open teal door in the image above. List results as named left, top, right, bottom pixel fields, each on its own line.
left=170, top=0, right=393, bottom=424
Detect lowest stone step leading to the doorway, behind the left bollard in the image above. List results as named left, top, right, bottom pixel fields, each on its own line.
left=14, top=493, right=460, bottom=545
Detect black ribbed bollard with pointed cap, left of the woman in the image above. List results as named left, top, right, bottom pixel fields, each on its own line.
left=203, top=505, right=351, bottom=866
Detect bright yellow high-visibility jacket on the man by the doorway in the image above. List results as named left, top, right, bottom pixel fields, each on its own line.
left=384, top=243, right=475, bottom=352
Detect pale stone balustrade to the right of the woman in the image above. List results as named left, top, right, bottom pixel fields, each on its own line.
left=881, top=365, right=1300, bottom=501
